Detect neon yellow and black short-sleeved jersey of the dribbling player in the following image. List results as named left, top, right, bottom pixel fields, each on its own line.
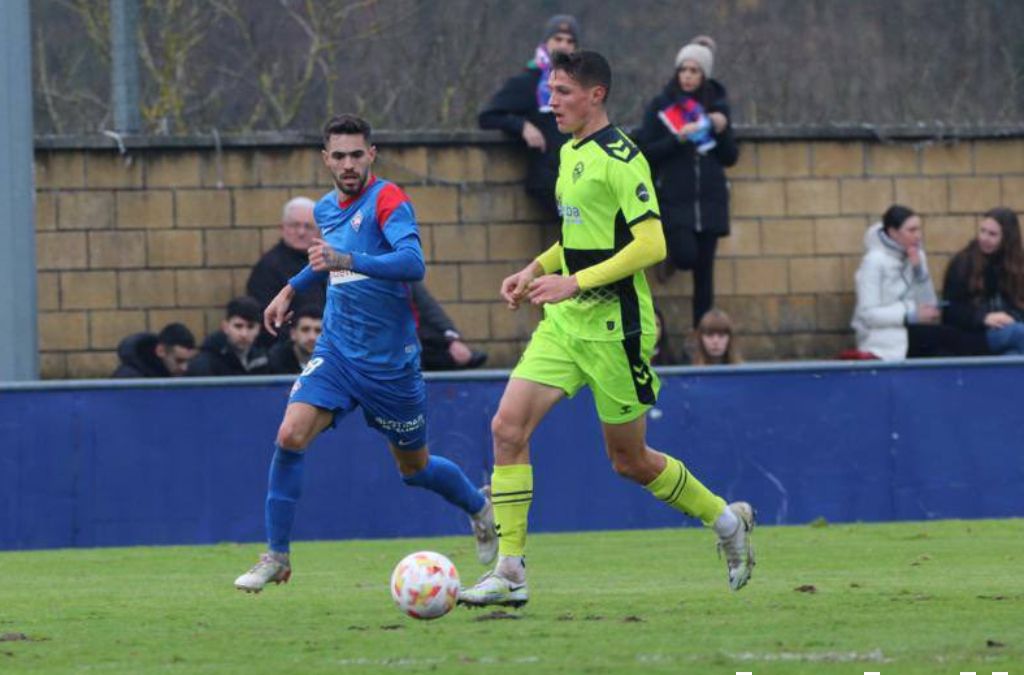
left=544, top=125, right=659, bottom=340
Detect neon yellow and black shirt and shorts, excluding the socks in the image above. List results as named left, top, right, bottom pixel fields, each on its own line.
left=512, top=126, right=664, bottom=424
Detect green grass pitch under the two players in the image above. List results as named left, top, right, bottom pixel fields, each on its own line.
left=0, top=519, right=1024, bottom=675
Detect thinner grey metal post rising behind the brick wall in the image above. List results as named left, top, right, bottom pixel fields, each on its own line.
left=111, top=0, right=141, bottom=133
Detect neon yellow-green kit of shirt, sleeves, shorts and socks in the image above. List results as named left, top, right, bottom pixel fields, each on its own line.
left=492, top=125, right=726, bottom=556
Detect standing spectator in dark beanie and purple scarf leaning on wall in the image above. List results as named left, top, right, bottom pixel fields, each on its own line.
left=478, top=14, right=580, bottom=220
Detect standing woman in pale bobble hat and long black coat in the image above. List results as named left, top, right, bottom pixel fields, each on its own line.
left=636, top=37, right=739, bottom=327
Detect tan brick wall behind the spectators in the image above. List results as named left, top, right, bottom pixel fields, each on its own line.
left=36, top=138, right=1024, bottom=378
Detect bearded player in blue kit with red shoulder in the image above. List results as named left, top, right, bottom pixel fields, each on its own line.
left=234, top=115, right=498, bottom=593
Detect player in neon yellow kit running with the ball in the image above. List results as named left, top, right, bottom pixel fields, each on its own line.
left=459, top=51, right=754, bottom=606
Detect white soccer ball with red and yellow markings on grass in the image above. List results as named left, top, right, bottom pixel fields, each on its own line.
left=391, top=551, right=459, bottom=619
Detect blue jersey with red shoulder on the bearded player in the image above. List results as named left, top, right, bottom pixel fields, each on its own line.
left=289, top=176, right=426, bottom=377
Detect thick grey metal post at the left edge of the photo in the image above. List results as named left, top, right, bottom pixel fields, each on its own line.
left=0, top=0, right=39, bottom=381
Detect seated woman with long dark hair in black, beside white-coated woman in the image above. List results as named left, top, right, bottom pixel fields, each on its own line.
left=942, top=208, right=1024, bottom=354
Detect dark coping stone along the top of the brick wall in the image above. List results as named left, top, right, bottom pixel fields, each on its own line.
left=29, top=124, right=1024, bottom=153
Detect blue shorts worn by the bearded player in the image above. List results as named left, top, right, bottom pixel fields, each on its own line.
left=288, top=349, right=427, bottom=450
